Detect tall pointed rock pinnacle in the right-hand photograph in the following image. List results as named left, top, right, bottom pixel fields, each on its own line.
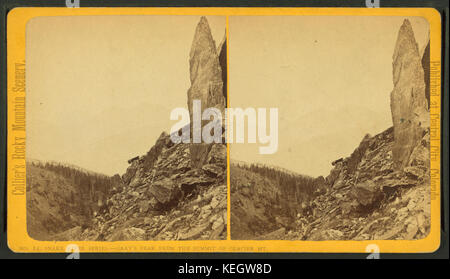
left=391, top=19, right=429, bottom=170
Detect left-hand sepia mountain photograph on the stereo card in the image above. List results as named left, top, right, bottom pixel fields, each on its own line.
left=24, top=15, right=227, bottom=241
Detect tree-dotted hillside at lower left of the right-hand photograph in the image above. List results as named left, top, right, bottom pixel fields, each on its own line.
left=230, top=161, right=324, bottom=239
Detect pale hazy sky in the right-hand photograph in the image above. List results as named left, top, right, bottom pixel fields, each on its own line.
left=229, top=16, right=428, bottom=176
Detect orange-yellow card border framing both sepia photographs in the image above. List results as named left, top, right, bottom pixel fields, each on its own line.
left=7, top=7, right=441, bottom=253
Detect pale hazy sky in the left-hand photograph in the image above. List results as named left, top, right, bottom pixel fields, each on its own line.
left=26, top=16, right=226, bottom=175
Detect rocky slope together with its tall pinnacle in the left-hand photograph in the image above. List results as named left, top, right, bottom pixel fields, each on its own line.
left=41, top=17, right=227, bottom=241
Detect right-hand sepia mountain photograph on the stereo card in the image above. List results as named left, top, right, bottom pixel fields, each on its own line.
left=229, top=16, right=430, bottom=241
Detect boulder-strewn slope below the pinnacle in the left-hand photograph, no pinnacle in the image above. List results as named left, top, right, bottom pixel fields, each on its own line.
left=67, top=133, right=227, bottom=241
